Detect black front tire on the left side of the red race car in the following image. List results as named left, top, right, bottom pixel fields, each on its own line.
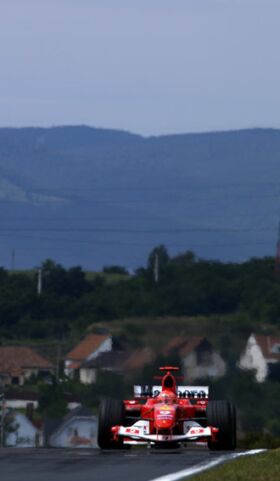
left=97, top=399, right=125, bottom=449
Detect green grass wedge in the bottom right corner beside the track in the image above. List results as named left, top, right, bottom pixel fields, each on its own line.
left=186, top=449, right=280, bottom=481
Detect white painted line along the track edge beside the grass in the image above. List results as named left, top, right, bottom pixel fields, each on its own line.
left=151, top=449, right=266, bottom=481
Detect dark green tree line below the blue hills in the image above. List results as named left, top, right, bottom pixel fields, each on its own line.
left=0, top=246, right=280, bottom=339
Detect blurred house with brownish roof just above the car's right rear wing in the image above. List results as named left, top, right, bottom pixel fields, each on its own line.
left=164, top=336, right=226, bottom=382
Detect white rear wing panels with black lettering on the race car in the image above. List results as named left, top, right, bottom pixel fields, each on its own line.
left=134, top=385, right=209, bottom=399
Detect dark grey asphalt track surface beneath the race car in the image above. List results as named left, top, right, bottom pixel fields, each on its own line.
left=0, top=447, right=236, bottom=481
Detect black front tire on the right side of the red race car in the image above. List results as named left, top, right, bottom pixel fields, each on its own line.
left=206, top=401, right=236, bottom=451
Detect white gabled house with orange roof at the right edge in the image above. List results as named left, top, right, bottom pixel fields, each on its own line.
left=238, top=334, right=280, bottom=382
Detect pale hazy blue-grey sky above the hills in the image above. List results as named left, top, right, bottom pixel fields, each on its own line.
left=0, top=0, right=280, bottom=135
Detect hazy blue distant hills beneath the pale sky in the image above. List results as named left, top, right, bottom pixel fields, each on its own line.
left=0, top=126, right=280, bottom=269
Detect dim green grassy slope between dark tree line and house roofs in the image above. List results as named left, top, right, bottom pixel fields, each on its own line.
left=86, top=314, right=280, bottom=358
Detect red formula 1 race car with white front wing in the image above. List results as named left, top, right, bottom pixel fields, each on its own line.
left=98, top=366, right=236, bottom=450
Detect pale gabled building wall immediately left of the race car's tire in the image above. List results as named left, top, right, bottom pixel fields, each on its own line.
left=49, top=416, right=97, bottom=448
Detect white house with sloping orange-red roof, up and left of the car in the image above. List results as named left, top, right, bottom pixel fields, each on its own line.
left=65, top=334, right=113, bottom=383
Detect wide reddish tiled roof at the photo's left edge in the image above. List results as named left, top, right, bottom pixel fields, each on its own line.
left=0, top=346, right=53, bottom=376
